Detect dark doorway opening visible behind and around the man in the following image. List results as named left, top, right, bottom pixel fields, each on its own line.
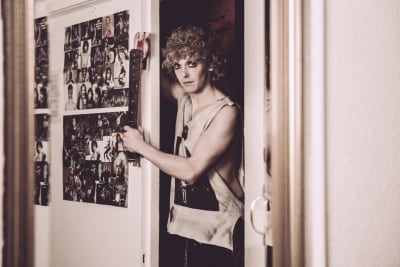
left=159, top=0, right=244, bottom=267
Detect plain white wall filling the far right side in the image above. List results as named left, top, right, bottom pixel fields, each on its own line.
left=325, top=0, right=400, bottom=267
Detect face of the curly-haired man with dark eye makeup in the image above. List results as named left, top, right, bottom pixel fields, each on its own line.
left=174, top=57, right=209, bottom=93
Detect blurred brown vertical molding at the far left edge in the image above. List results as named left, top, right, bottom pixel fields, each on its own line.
left=2, top=0, right=34, bottom=267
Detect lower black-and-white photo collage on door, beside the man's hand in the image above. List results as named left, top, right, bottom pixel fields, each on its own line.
left=63, top=112, right=128, bottom=207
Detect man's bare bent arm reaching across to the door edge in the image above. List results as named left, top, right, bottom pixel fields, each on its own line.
left=121, top=106, right=238, bottom=184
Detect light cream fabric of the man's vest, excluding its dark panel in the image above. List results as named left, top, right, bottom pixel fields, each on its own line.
left=168, top=94, right=244, bottom=250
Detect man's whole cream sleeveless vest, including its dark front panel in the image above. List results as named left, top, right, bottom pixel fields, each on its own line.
left=167, top=94, right=244, bottom=250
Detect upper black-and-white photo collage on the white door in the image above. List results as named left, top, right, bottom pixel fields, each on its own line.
left=64, top=11, right=129, bottom=111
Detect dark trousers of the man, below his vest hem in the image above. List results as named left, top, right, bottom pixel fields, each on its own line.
left=163, top=219, right=244, bottom=267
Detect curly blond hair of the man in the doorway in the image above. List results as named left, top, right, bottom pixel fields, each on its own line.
left=162, top=25, right=226, bottom=80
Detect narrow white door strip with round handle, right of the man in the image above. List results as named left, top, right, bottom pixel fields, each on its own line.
left=244, top=0, right=269, bottom=267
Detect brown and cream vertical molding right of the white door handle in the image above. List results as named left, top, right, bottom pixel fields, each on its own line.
left=271, top=0, right=305, bottom=267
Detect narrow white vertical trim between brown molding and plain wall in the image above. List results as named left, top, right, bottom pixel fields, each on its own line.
left=304, top=0, right=328, bottom=267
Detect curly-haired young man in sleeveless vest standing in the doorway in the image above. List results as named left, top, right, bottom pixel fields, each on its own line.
left=121, top=26, right=244, bottom=267
